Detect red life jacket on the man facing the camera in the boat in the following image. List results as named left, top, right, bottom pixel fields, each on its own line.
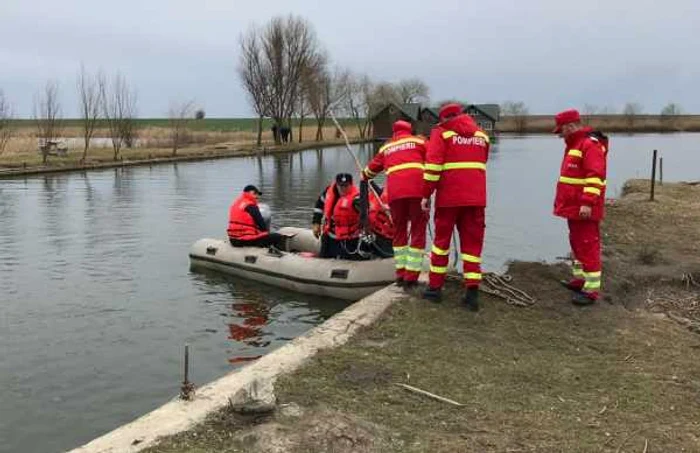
left=323, top=183, right=360, bottom=240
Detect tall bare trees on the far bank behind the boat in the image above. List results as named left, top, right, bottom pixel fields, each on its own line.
left=238, top=16, right=429, bottom=146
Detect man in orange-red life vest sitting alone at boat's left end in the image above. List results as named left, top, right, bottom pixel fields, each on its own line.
left=227, top=184, right=282, bottom=248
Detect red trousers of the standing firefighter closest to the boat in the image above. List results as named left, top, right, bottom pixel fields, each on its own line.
left=389, top=198, right=428, bottom=282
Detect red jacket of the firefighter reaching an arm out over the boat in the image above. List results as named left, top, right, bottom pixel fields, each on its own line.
left=362, top=131, right=425, bottom=202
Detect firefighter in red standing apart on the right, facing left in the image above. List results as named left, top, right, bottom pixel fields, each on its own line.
left=554, top=110, right=608, bottom=305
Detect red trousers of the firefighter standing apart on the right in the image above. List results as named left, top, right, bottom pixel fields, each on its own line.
left=568, top=219, right=602, bottom=299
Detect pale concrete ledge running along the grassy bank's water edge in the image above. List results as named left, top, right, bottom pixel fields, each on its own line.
left=71, top=285, right=404, bottom=453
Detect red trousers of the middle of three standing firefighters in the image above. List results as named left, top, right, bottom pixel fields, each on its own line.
left=429, top=206, right=486, bottom=288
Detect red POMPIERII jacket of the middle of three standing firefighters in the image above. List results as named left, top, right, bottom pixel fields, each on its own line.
left=422, top=114, right=490, bottom=208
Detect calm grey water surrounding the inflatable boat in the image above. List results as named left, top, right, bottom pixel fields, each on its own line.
left=0, top=134, right=700, bottom=453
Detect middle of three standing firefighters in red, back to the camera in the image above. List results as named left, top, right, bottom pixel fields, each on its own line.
left=421, top=104, right=490, bottom=311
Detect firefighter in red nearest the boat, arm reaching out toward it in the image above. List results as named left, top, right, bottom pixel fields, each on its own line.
left=362, top=121, right=428, bottom=287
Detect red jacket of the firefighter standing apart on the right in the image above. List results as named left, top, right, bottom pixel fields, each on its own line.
left=554, top=127, right=608, bottom=220
